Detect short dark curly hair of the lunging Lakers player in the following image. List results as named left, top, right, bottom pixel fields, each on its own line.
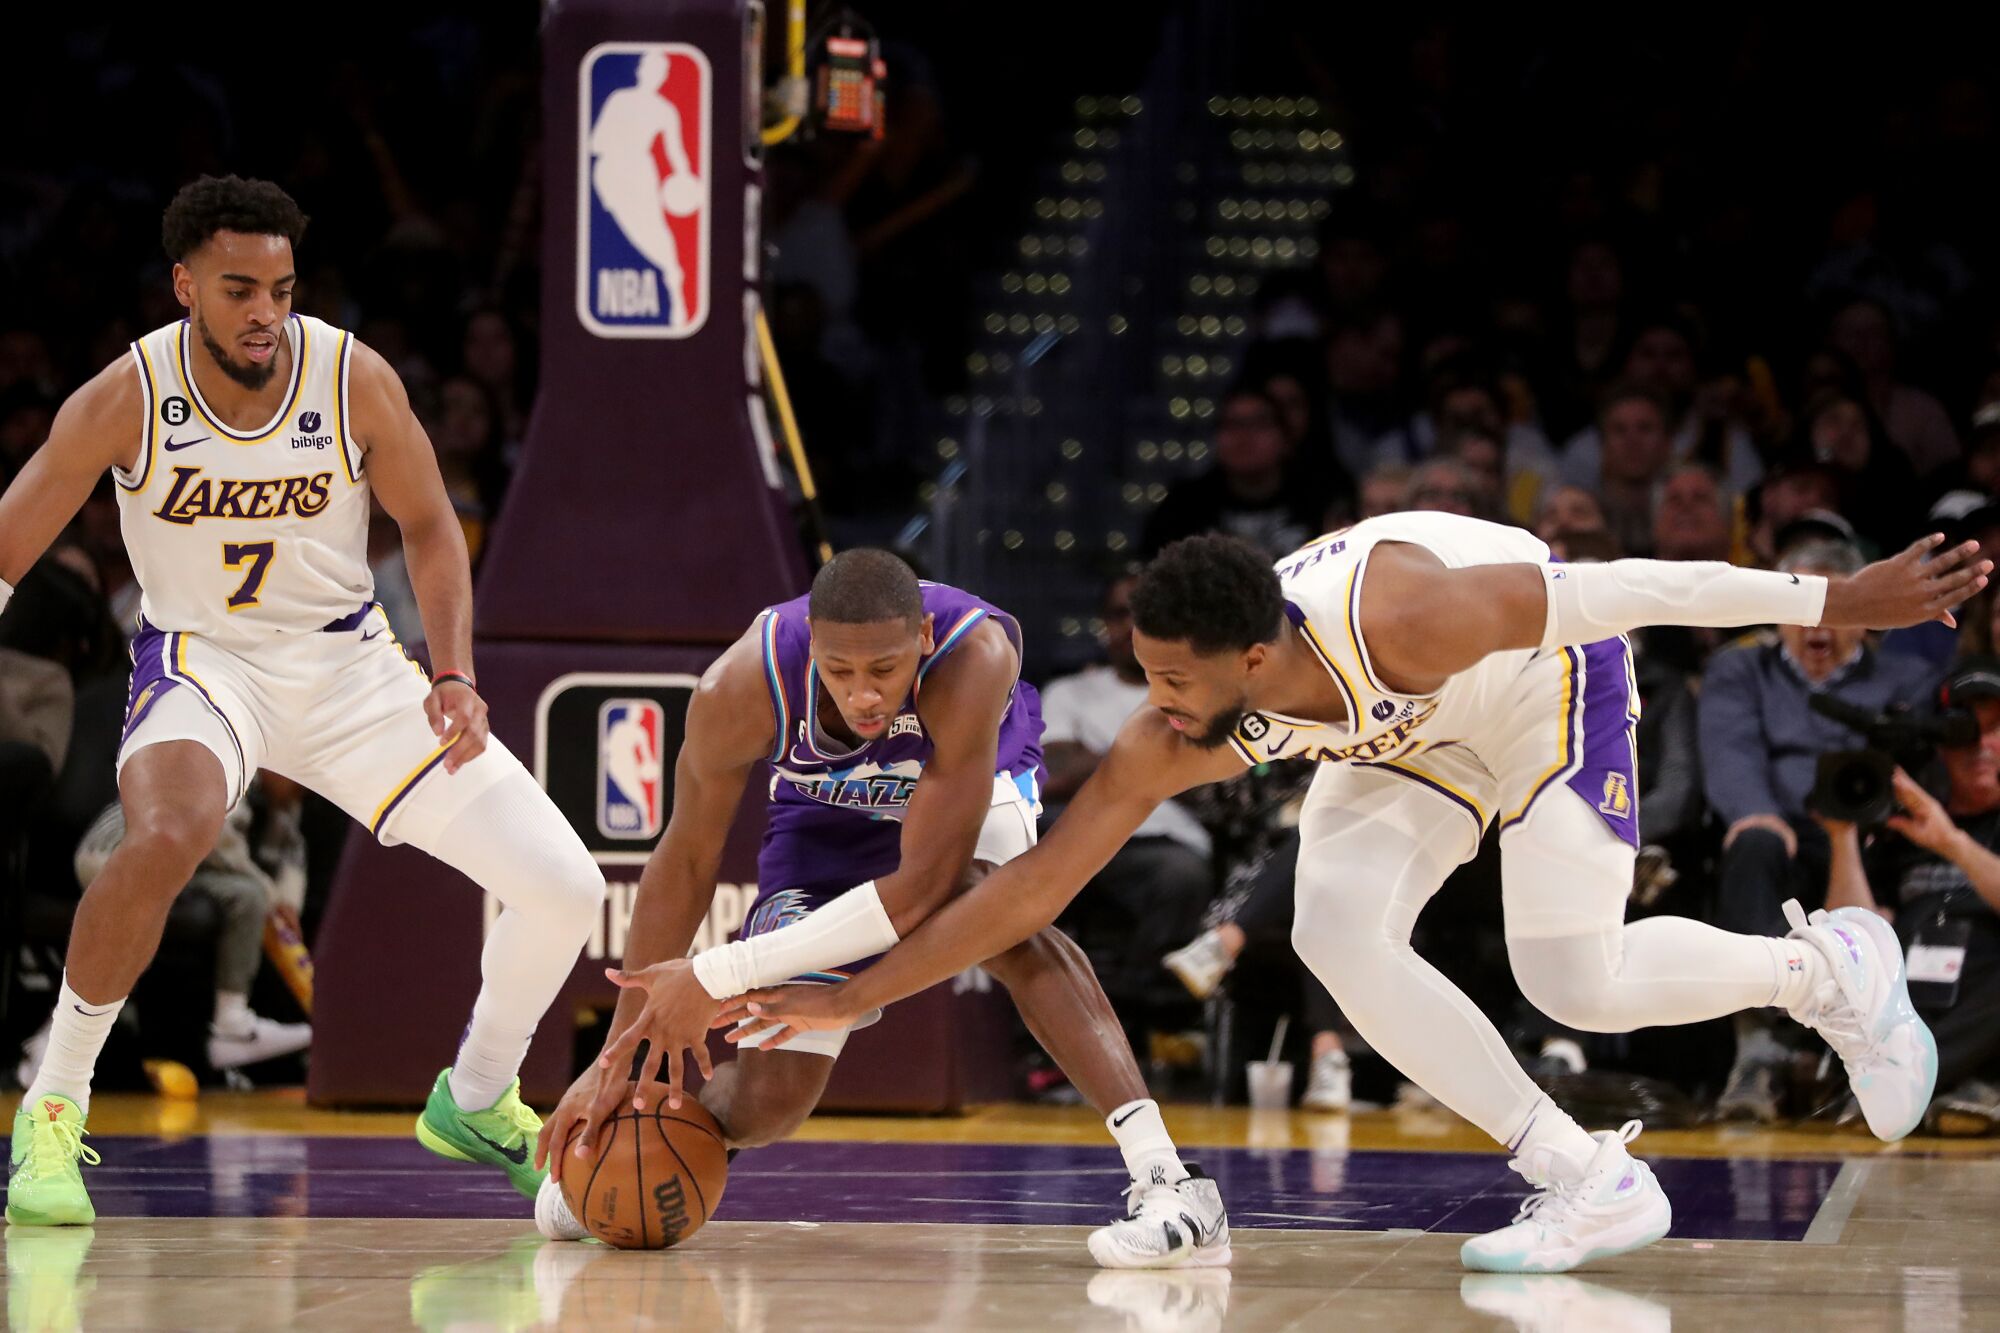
left=1132, top=532, right=1284, bottom=654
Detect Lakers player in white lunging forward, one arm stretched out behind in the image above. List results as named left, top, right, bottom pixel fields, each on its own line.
left=724, top=514, right=1992, bottom=1273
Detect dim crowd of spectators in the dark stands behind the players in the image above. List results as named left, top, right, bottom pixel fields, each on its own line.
left=0, top=18, right=2000, bottom=1133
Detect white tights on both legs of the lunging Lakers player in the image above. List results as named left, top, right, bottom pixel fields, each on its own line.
left=1292, top=787, right=1808, bottom=1143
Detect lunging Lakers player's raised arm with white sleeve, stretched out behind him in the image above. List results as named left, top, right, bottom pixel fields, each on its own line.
left=1362, top=534, right=1992, bottom=693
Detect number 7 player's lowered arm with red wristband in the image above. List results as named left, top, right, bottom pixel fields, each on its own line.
left=348, top=340, right=486, bottom=773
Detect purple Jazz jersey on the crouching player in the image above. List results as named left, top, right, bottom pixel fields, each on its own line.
left=758, top=582, right=1042, bottom=901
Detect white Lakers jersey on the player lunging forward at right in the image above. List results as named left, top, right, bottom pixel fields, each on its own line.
left=1230, top=512, right=1548, bottom=765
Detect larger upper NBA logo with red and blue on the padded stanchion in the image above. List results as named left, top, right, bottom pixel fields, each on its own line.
left=576, top=42, right=714, bottom=338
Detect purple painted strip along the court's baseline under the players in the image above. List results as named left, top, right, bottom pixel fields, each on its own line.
left=66, top=1135, right=1840, bottom=1241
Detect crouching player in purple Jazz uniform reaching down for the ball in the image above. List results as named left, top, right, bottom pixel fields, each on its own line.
left=536, top=548, right=1230, bottom=1267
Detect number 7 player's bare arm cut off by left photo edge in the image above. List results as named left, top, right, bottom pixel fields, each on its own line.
left=0, top=356, right=146, bottom=604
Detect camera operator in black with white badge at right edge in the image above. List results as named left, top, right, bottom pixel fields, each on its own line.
left=1820, top=656, right=2000, bottom=1135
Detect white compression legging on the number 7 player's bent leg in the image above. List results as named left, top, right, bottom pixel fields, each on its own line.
left=398, top=769, right=604, bottom=1111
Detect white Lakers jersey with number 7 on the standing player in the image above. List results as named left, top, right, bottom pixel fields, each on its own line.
left=112, top=314, right=374, bottom=648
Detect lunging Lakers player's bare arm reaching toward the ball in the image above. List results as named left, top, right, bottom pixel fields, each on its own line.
left=724, top=709, right=1242, bottom=1041
